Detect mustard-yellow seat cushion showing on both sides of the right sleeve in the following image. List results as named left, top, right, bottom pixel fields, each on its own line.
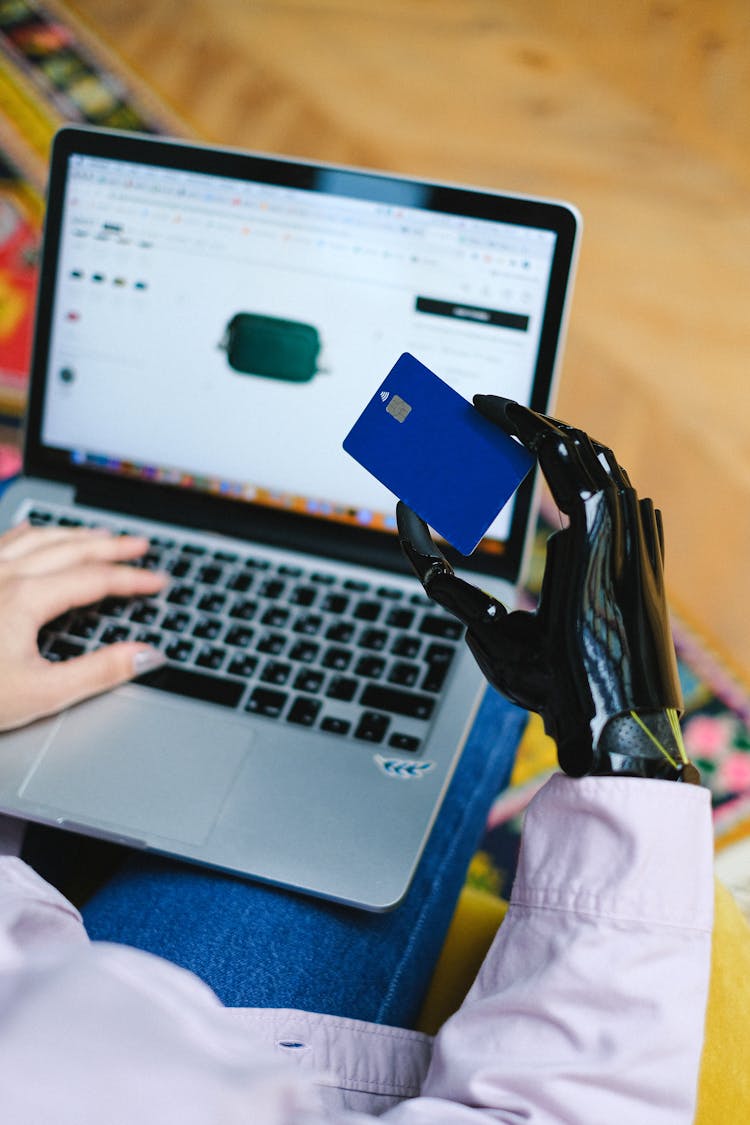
left=418, top=882, right=750, bottom=1125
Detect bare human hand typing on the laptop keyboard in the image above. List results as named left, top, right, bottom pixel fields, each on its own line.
left=0, top=523, right=168, bottom=730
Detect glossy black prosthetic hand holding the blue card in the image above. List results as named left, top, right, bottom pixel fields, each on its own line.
left=397, top=395, right=699, bottom=783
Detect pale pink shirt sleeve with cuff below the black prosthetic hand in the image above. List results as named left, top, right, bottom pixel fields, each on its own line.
left=386, top=775, right=713, bottom=1125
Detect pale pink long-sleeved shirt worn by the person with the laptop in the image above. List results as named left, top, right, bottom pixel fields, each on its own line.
left=0, top=775, right=713, bottom=1125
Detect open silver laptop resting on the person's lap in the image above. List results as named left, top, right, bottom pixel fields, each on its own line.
left=0, top=127, right=579, bottom=911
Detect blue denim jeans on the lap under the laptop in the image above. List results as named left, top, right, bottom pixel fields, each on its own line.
left=76, top=689, right=526, bottom=1027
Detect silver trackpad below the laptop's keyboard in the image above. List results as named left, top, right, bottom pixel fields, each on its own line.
left=20, top=692, right=252, bottom=844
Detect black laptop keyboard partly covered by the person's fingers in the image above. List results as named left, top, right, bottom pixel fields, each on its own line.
left=28, top=506, right=463, bottom=753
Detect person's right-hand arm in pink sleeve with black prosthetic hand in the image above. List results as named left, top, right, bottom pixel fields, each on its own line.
left=384, top=396, right=713, bottom=1125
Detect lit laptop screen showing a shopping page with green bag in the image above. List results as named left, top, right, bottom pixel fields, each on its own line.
left=27, top=134, right=571, bottom=580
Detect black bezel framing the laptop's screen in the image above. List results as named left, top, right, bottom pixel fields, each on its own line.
left=24, top=126, right=579, bottom=582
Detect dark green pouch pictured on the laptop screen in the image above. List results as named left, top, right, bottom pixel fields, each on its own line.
left=219, top=313, right=320, bottom=383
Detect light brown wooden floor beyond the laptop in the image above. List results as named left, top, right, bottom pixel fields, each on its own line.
left=67, top=0, right=750, bottom=683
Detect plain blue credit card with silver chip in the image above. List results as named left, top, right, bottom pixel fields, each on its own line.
left=344, top=352, right=534, bottom=555
